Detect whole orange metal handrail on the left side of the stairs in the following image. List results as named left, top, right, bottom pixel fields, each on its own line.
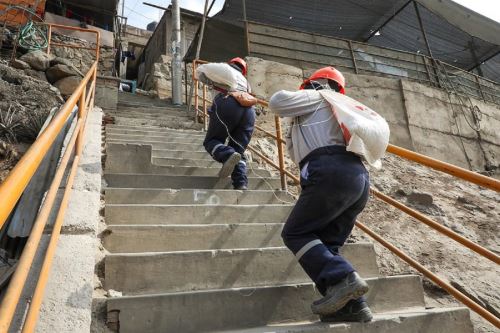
left=0, top=24, right=100, bottom=333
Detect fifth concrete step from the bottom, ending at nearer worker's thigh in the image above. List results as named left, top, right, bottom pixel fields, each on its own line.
left=105, top=204, right=293, bottom=224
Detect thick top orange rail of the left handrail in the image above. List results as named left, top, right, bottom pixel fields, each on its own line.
left=0, top=63, right=97, bottom=228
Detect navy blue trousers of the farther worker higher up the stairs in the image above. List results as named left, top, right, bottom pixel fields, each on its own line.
left=203, top=94, right=255, bottom=187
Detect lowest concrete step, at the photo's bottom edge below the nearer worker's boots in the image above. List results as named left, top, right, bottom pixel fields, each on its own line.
left=223, top=308, right=474, bottom=333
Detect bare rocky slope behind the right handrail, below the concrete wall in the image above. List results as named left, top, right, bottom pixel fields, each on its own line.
left=360, top=155, right=500, bottom=333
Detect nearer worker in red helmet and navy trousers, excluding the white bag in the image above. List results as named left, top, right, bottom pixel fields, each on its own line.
left=269, top=67, right=372, bottom=322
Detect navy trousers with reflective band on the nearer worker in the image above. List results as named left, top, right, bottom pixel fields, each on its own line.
left=282, top=146, right=370, bottom=295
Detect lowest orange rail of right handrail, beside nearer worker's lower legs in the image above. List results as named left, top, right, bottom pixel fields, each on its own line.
left=356, top=222, right=500, bottom=328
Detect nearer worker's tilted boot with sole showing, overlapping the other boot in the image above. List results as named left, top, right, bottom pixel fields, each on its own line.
left=311, top=272, right=368, bottom=316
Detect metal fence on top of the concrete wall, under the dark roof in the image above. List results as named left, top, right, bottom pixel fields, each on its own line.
left=246, top=22, right=500, bottom=105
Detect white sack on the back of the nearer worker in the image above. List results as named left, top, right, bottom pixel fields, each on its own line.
left=319, top=90, right=390, bottom=168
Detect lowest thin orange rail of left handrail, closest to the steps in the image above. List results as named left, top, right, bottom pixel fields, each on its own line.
left=22, top=154, right=83, bottom=333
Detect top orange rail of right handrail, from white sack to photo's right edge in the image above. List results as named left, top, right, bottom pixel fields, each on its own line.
left=387, top=144, right=500, bottom=192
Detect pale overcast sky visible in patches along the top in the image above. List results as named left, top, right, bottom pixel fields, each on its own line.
left=119, top=0, right=500, bottom=29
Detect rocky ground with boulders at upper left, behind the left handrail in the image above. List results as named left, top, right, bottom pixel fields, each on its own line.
left=0, top=28, right=113, bottom=180
